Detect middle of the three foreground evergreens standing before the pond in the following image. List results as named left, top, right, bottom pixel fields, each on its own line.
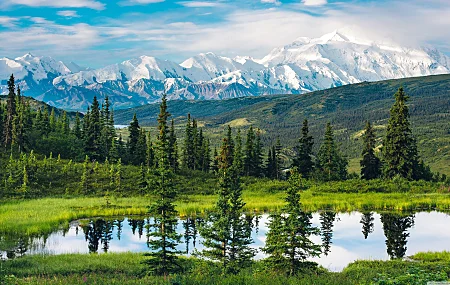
left=200, top=137, right=255, bottom=274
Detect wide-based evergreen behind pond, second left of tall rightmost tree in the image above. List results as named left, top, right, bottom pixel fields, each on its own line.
left=317, top=123, right=348, bottom=181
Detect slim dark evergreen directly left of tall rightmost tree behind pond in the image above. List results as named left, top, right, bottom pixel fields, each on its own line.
left=360, top=122, right=381, bottom=180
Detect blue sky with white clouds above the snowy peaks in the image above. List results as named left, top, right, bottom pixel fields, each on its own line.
left=0, top=0, right=450, bottom=68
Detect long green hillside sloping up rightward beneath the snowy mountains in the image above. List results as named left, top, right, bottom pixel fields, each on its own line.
left=115, top=75, right=450, bottom=174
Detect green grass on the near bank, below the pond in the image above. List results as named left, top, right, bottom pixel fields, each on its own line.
left=3, top=252, right=450, bottom=285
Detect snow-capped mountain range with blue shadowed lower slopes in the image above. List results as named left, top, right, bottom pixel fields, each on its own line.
left=0, top=31, right=450, bottom=110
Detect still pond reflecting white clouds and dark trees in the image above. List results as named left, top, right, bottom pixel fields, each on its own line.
left=0, top=212, right=450, bottom=271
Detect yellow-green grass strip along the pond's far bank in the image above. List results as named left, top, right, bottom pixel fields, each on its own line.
left=0, top=187, right=450, bottom=235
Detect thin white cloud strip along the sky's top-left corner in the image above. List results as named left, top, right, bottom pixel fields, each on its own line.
left=0, top=0, right=105, bottom=10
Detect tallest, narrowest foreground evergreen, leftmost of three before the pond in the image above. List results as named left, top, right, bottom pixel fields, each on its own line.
left=145, top=95, right=181, bottom=276
